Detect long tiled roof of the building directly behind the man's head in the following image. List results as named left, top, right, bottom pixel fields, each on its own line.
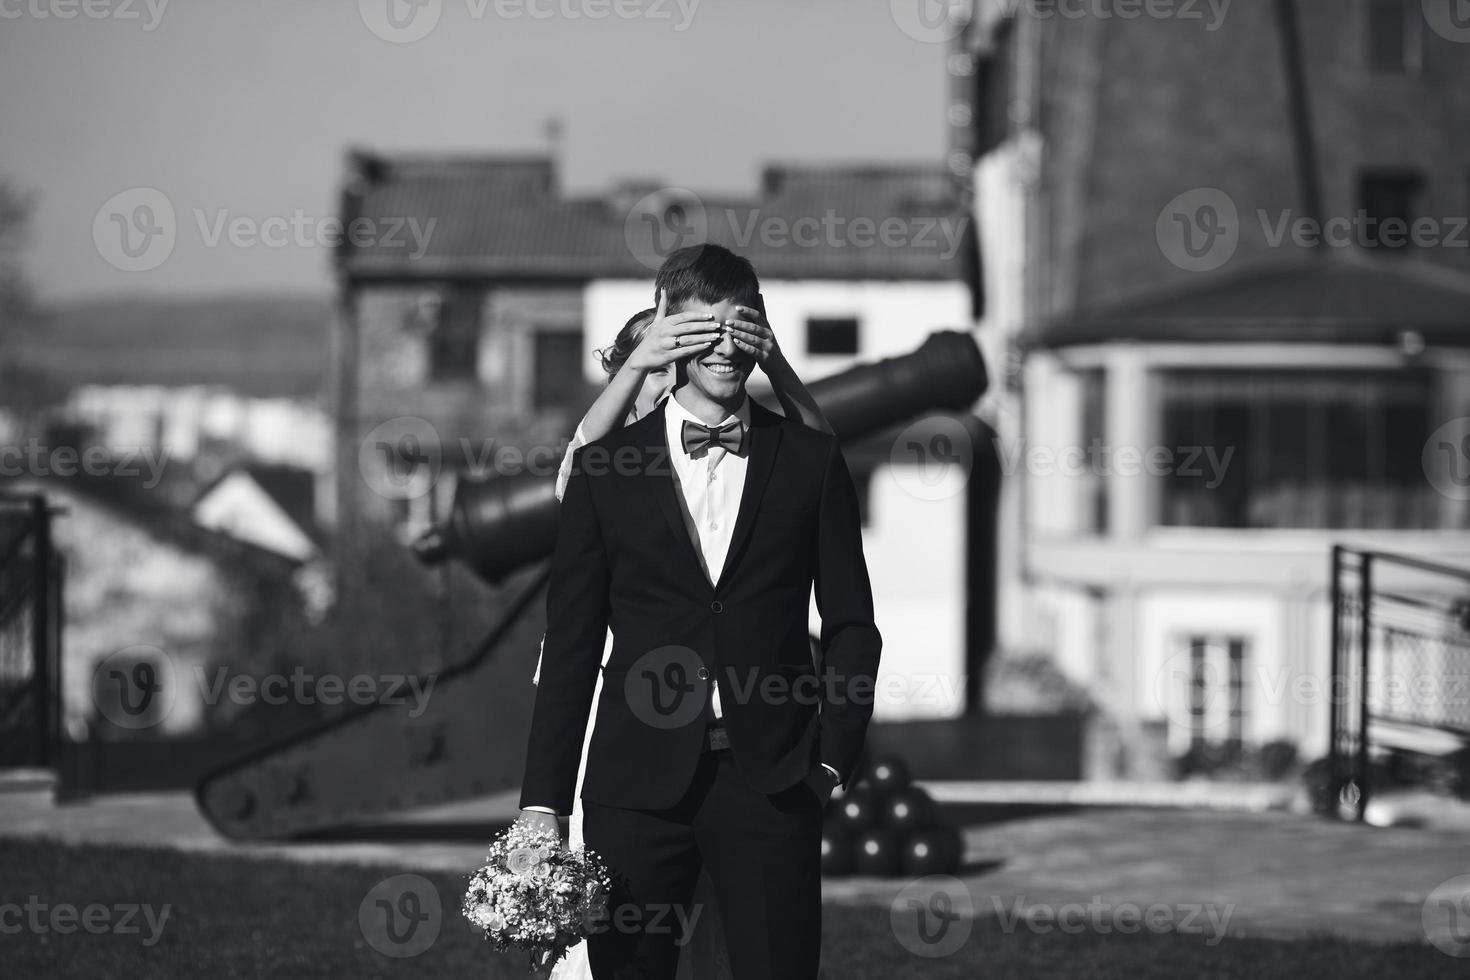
left=338, top=154, right=975, bottom=281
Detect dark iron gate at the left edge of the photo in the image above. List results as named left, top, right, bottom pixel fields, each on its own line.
left=0, top=494, right=62, bottom=768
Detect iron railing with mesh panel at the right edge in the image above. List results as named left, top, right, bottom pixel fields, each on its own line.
left=1329, top=545, right=1470, bottom=820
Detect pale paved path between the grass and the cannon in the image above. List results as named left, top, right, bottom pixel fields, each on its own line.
left=0, top=786, right=1470, bottom=942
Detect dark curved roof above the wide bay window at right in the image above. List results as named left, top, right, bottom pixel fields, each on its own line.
left=1028, top=253, right=1470, bottom=347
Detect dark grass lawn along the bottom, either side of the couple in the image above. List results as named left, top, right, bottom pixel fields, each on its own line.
left=0, top=842, right=1470, bottom=980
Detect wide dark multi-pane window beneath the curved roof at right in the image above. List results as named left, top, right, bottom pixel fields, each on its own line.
left=1158, top=370, right=1442, bottom=529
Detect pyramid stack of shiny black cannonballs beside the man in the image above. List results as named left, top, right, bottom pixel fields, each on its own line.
left=822, top=758, right=964, bottom=877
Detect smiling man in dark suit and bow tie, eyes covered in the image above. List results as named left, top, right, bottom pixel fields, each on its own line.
left=520, top=245, right=882, bottom=980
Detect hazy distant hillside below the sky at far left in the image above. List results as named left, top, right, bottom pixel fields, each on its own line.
left=4, top=297, right=331, bottom=397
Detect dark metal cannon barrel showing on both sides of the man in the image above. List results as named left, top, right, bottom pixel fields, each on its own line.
left=413, top=331, right=986, bottom=582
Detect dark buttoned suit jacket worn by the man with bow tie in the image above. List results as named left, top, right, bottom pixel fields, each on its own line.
left=520, top=403, right=882, bottom=814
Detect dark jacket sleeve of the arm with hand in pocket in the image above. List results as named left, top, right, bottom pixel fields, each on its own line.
left=814, top=439, right=883, bottom=785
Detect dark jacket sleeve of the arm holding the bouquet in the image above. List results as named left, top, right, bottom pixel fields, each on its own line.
left=520, top=452, right=610, bottom=815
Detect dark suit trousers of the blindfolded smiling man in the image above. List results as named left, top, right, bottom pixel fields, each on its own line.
left=582, top=751, right=822, bottom=980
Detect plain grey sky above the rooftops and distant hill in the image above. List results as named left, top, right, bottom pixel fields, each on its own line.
left=0, top=0, right=947, bottom=301
